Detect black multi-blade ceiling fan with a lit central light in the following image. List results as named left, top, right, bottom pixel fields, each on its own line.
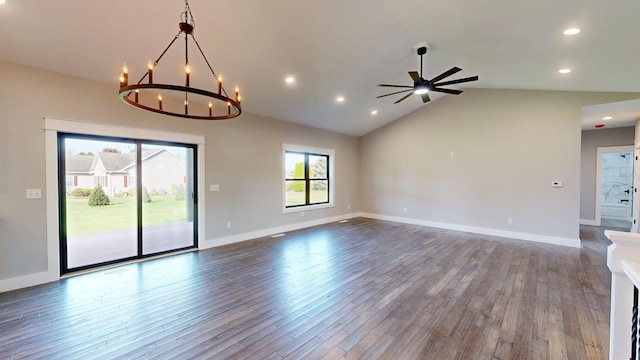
left=376, top=46, right=478, bottom=104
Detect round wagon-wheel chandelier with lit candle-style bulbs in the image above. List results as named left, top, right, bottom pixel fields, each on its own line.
left=119, top=0, right=242, bottom=120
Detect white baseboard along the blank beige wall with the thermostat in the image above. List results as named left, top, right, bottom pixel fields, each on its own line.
left=359, top=213, right=580, bottom=247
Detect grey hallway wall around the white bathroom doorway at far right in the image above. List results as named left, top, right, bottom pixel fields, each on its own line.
left=580, top=127, right=635, bottom=223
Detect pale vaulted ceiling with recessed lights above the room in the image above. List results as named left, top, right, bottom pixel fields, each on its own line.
left=0, top=0, right=640, bottom=136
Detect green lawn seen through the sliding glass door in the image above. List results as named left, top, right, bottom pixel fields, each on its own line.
left=67, top=195, right=187, bottom=235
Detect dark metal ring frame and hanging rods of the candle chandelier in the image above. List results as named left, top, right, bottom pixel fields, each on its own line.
left=119, top=0, right=242, bottom=120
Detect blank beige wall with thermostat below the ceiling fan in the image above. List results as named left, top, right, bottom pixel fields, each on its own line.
left=360, top=89, right=639, bottom=244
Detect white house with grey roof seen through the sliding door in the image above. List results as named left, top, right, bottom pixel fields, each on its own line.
left=65, top=148, right=186, bottom=196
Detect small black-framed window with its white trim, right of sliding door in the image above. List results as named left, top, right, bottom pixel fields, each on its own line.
left=283, top=145, right=334, bottom=212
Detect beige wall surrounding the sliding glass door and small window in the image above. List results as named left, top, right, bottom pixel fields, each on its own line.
left=0, top=62, right=359, bottom=291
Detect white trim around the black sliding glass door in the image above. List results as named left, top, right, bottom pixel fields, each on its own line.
left=44, top=117, right=206, bottom=282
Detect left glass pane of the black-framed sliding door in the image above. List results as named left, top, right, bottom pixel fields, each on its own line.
left=63, top=137, right=138, bottom=269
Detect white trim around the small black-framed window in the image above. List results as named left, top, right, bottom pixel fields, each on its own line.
left=282, top=144, right=336, bottom=214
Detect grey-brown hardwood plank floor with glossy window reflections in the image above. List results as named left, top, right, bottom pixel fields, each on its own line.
left=0, top=219, right=610, bottom=360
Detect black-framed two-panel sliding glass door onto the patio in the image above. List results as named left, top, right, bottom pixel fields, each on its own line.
left=58, top=134, right=197, bottom=273
